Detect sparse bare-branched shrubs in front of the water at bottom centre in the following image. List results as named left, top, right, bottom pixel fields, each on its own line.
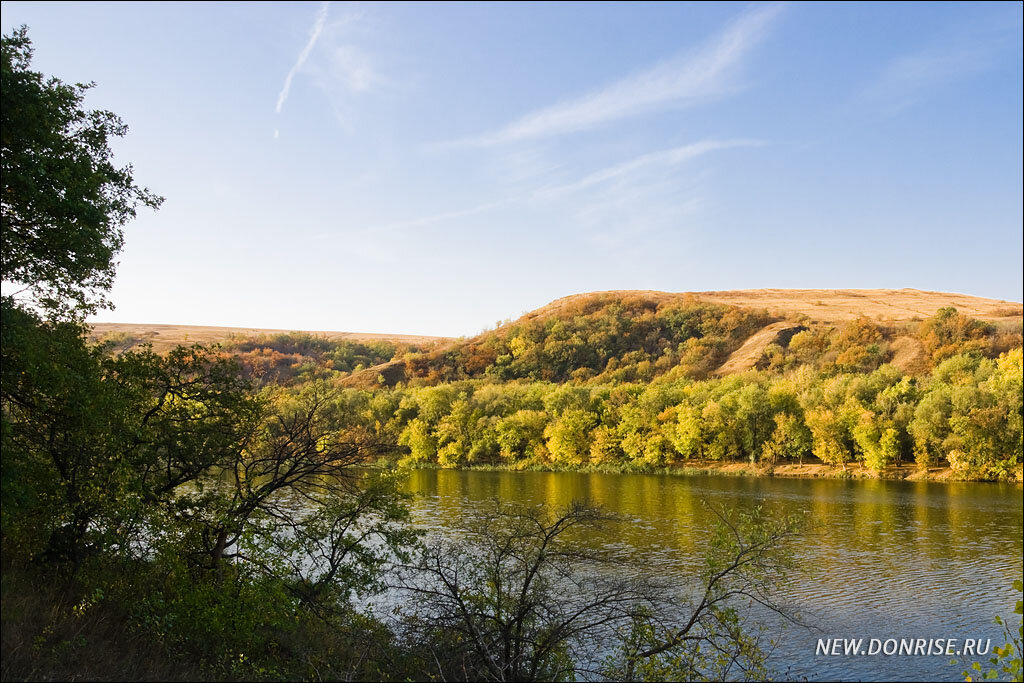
left=396, top=502, right=798, bottom=681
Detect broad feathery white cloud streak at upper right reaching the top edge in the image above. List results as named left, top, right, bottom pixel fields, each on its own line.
left=447, top=4, right=782, bottom=146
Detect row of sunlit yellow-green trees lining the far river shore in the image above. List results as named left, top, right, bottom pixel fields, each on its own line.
left=356, top=349, right=1024, bottom=479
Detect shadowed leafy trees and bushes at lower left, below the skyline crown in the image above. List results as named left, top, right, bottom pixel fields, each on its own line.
left=2, top=300, right=417, bottom=678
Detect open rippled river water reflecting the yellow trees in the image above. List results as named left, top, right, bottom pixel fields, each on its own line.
left=397, top=470, right=1024, bottom=681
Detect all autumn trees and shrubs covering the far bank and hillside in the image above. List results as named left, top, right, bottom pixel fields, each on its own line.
left=101, top=293, right=1024, bottom=481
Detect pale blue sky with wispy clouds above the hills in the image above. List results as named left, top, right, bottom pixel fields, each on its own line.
left=2, top=2, right=1024, bottom=336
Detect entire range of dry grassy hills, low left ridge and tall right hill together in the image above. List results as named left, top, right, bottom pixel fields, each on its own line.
left=93, top=289, right=1022, bottom=388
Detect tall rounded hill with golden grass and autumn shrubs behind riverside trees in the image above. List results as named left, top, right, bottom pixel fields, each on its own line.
left=345, top=289, right=1022, bottom=388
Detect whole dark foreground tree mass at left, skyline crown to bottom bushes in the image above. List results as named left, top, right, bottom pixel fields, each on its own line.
left=0, top=28, right=416, bottom=680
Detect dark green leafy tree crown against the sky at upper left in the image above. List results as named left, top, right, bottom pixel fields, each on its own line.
left=0, top=27, right=163, bottom=316
